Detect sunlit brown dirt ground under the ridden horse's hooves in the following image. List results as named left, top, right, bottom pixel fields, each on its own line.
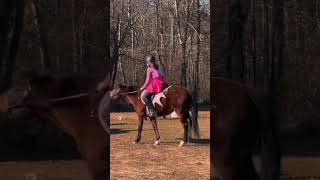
left=110, top=112, right=210, bottom=179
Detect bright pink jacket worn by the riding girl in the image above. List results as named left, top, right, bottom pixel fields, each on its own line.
left=142, top=67, right=164, bottom=93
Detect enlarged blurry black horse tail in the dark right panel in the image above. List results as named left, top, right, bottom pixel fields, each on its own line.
left=259, top=95, right=281, bottom=180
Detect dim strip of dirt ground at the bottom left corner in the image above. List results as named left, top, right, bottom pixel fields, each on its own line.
left=0, top=160, right=90, bottom=180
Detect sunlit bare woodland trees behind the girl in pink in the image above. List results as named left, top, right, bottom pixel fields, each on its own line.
left=110, top=0, right=210, bottom=103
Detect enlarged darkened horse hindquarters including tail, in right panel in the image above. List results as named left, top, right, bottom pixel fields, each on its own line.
left=211, top=78, right=280, bottom=180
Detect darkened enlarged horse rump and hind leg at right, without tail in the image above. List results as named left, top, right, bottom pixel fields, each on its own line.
left=211, top=78, right=257, bottom=180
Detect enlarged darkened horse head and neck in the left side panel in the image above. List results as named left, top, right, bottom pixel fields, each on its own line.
left=1, top=73, right=110, bottom=180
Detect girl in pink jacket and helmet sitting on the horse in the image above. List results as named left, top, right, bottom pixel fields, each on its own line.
left=140, top=55, right=164, bottom=118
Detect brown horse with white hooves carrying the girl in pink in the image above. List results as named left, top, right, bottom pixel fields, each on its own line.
left=110, top=85, right=199, bottom=146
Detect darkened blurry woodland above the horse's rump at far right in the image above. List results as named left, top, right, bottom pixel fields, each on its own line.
left=211, top=0, right=320, bottom=130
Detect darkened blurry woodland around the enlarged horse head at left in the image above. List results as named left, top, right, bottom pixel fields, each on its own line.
left=0, top=0, right=111, bottom=161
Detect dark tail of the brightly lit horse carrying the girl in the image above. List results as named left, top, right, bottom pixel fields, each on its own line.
left=188, top=93, right=200, bottom=139
